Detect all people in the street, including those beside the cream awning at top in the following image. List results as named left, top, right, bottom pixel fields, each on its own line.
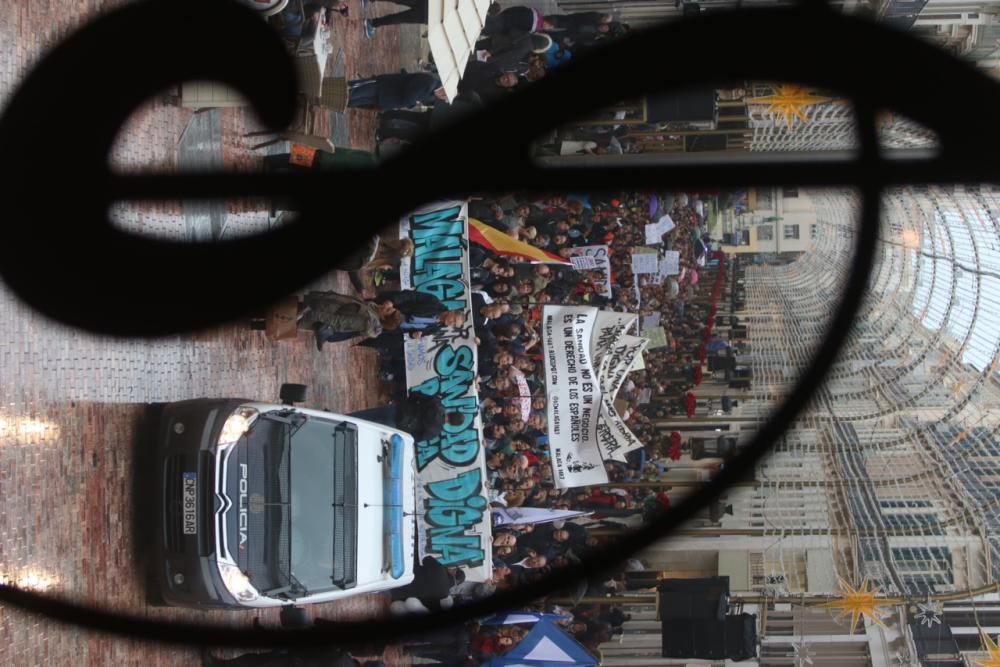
left=223, top=0, right=748, bottom=666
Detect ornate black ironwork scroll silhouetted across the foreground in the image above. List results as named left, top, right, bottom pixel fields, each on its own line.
left=0, top=0, right=1000, bottom=646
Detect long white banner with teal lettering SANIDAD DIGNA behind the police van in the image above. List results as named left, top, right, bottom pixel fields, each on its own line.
left=400, top=201, right=493, bottom=581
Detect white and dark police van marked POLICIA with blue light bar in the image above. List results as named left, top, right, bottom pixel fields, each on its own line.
left=152, top=385, right=416, bottom=608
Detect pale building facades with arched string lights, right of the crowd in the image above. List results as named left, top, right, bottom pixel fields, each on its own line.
left=605, top=187, right=1000, bottom=667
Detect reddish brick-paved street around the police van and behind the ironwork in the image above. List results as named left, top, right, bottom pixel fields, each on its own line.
left=0, top=0, right=419, bottom=666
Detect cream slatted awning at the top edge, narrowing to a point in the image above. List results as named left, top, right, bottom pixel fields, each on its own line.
left=427, top=0, right=492, bottom=102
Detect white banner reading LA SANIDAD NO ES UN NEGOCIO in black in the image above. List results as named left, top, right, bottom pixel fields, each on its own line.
left=542, top=306, right=608, bottom=489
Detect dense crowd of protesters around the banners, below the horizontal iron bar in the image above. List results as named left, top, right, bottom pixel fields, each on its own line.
left=248, top=187, right=728, bottom=660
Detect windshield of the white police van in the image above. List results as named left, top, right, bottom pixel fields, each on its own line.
left=290, top=417, right=358, bottom=594
